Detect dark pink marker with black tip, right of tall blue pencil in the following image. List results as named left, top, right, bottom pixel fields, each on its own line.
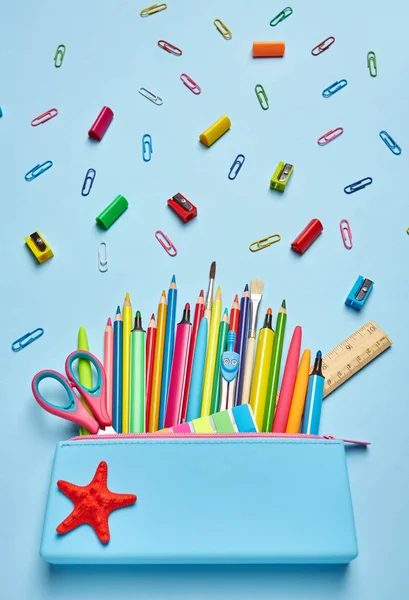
left=164, top=304, right=192, bottom=427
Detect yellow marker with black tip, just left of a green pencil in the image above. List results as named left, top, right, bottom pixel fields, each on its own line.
left=250, top=308, right=274, bottom=431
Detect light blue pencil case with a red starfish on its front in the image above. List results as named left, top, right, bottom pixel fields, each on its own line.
left=41, top=434, right=364, bottom=565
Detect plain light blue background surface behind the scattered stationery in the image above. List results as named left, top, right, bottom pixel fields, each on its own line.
left=0, top=0, right=409, bottom=600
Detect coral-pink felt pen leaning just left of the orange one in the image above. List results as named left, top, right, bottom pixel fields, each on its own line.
left=273, top=325, right=302, bottom=433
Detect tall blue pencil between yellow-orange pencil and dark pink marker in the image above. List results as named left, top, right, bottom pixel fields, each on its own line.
left=159, top=276, right=178, bottom=429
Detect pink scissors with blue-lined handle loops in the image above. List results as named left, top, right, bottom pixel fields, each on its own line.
left=31, top=350, right=111, bottom=434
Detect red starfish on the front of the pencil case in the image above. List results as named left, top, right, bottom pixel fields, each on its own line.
left=57, top=461, right=136, bottom=544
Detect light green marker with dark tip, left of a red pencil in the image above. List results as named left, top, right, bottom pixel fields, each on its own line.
left=129, top=310, right=146, bottom=433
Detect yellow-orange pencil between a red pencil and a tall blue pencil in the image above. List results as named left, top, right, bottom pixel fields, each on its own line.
left=148, top=290, right=168, bottom=433
